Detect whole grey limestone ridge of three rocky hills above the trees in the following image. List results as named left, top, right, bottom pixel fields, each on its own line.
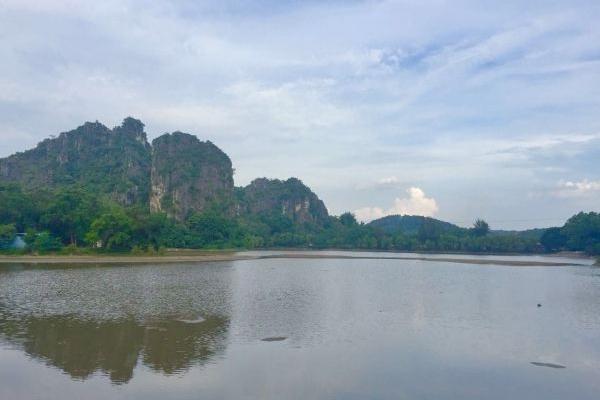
left=0, top=118, right=328, bottom=224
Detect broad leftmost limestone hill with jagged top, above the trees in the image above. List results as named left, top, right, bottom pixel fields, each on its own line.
left=0, top=118, right=150, bottom=205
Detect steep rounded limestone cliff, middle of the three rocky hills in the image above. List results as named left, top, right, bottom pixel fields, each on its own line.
left=150, top=132, right=233, bottom=221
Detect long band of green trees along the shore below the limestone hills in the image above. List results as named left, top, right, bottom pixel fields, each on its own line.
left=0, top=185, right=600, bottom=254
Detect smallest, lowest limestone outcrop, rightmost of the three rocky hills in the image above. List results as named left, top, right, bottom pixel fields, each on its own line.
left=239, top=178, right=329, bottom=224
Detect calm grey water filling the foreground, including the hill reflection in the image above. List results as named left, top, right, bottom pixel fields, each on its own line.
left=0, top=253, right=600, bottom=400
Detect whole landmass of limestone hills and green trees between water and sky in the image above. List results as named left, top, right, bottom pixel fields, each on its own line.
left=0, top=117, right=600, bottom=254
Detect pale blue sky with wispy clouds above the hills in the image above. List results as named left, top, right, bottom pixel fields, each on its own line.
left=0, top=0, right=600, bottom=229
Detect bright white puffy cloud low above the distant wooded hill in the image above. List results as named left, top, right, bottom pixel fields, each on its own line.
left=354, top=187, right=439, bottom=222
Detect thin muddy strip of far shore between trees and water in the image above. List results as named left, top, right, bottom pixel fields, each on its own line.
left=0, top=250, right=588, bottom=267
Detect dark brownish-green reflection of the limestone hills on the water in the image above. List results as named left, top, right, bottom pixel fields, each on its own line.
left=0, top=310, right=229, bottom=383
